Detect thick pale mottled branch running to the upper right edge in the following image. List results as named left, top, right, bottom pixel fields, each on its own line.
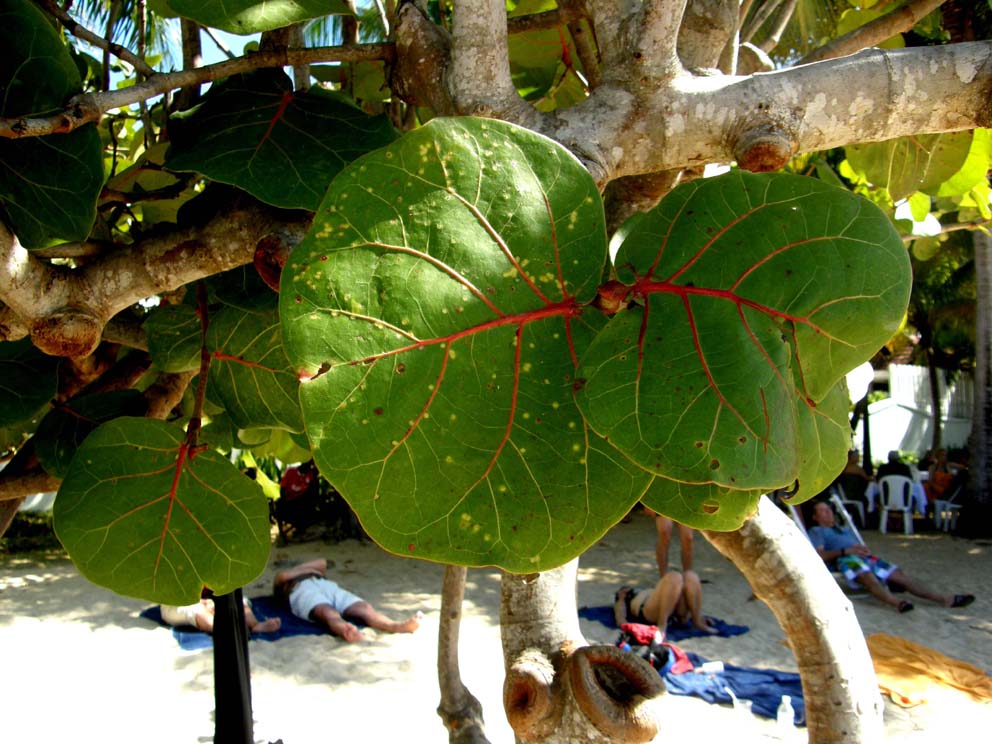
left=545, top=41, right=992, bottom=187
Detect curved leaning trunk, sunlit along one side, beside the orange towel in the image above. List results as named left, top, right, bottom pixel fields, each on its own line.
left=703, top=498, right=883, bottom=744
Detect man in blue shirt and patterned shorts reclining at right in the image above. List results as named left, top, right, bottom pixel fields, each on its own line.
left=809, top=501, right=975, bottom=612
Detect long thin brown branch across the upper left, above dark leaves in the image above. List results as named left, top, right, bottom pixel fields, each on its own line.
left=0, top=44, right=395, bottom=139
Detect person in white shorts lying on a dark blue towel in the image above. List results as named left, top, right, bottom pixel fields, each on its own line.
left=272, top=558, right=424, bottom=643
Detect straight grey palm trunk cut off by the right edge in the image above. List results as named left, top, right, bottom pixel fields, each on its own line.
left=969, top=231, right=992, bottom=534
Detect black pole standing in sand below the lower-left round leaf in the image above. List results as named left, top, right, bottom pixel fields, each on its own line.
left=214, top=589, right=255, bottom=744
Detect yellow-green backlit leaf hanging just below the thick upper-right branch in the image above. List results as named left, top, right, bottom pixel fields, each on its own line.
left=846, top=132, right=972, bottom=202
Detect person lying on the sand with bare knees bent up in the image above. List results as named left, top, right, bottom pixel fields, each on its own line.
left=613, top=570, right=719, bottom=633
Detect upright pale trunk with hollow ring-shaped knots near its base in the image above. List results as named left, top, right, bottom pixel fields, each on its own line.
left=500, top=560, right=665, bottom=744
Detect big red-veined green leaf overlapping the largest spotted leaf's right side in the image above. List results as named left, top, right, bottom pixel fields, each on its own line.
left=576, top=172, right=911, bottom=491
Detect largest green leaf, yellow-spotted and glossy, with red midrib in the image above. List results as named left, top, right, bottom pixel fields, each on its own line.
left=280, top=118, right=649, bottom=571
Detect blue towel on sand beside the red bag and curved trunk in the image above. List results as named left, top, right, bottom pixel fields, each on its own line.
left=659, top=653, right=806, bottom=726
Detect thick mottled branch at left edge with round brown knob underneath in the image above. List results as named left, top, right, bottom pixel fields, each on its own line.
left=0, top=202, right=312, bottom=357
